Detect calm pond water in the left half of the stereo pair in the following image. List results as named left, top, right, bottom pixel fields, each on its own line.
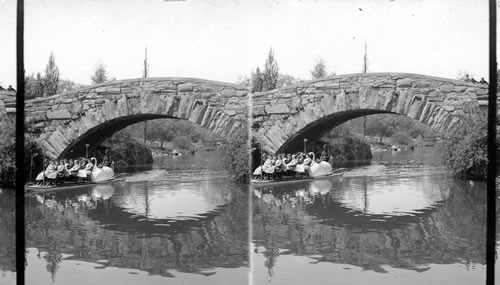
left=26, top=152, right=249, bottom=284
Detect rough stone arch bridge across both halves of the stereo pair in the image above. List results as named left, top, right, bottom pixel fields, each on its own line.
left=8, top=73, right=488, bottom=158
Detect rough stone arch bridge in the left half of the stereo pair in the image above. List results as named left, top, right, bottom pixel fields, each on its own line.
left=26, top=78, right=248, bottom=158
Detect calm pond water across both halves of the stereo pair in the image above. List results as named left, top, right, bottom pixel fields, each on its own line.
left=0, top=148, right=500, bottom=285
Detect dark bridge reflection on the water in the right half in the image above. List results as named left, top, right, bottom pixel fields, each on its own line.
left=253, top=178, right=486, bottom=272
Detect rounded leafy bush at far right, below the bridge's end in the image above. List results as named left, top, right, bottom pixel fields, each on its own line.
left=441, top=115, right=490, bottom=180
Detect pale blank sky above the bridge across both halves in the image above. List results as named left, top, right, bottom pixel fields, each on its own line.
left=0, top=0, right=488, bottom=86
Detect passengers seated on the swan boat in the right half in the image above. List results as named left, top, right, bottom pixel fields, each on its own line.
left=253, top=152, right=312, bottom=180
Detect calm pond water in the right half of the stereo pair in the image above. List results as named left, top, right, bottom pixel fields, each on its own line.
left=251, top=148, right=486, bottom=285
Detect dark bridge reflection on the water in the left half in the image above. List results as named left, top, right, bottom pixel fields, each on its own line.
left=26, top=182, right=248, bottom=277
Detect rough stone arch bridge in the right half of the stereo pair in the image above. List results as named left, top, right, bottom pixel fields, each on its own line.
left=252, top=73, right=488, bottom=152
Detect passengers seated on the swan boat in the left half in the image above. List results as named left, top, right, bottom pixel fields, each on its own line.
left=36, top=157, right=111, bottom=185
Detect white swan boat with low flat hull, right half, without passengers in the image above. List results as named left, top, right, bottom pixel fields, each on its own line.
left=250, top=152, right=347, bottom=185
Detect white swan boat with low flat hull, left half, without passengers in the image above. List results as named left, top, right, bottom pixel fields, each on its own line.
left=24, top=157, right=127, bottom=192
